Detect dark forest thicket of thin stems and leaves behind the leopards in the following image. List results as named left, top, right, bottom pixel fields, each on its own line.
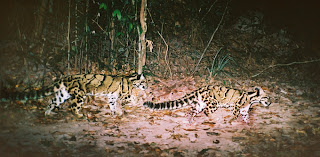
left=0, top=0, right=320, bottom=88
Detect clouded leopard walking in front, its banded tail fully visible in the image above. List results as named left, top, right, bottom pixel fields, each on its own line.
left=143, top=85, right=271, bottom=122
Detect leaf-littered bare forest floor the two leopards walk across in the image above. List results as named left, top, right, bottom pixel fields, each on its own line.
left=0, top=70, right=320, bottom=156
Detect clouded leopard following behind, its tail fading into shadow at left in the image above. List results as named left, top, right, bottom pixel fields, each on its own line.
left=2, top=74, right=147, bottom=117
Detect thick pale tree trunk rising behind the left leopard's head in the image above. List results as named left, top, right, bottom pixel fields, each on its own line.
left=138, top=0, right=147, bottom=74
